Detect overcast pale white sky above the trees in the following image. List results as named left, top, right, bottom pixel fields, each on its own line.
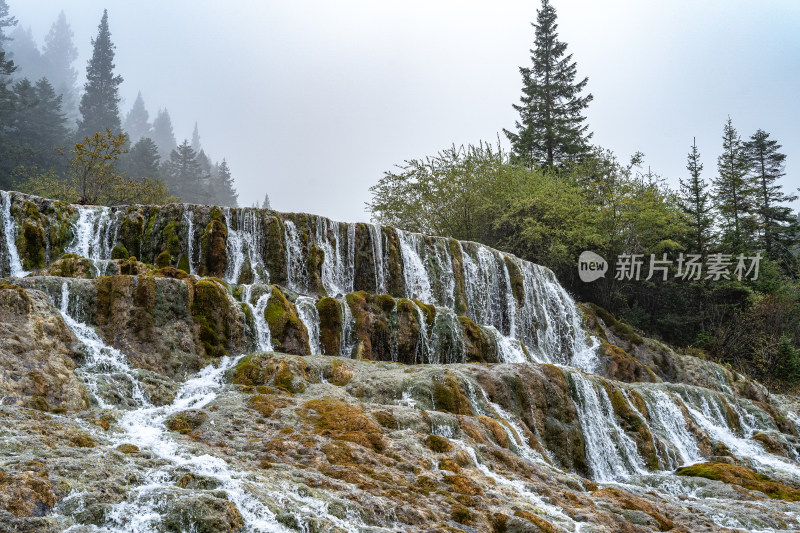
left=7, top=0, right=800, bottom=221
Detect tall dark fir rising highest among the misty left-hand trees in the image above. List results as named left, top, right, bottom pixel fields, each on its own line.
left=78, top=10, right=122, bottom=137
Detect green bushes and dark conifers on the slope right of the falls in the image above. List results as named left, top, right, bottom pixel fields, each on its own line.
left=368, top=0, right=800, bottom=386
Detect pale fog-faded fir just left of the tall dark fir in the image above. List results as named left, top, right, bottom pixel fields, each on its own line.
left=42, top=11, right=78, bottom=127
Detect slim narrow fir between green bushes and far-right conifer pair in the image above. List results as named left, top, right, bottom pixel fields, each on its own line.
left=680, top=139, right=714, bottom=253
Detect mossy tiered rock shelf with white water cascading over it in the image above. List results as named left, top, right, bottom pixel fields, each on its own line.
left=0, top=193, right=800, bottom=532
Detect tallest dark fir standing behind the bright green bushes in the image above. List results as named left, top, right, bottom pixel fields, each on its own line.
left=503, top=0, right=593, bottom=168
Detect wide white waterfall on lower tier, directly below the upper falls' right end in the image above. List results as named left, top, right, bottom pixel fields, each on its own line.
left=569, top=371, right=644, bottom=482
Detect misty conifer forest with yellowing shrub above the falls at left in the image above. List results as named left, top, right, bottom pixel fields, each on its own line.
left=0, top=0, right=238, bottom=207
